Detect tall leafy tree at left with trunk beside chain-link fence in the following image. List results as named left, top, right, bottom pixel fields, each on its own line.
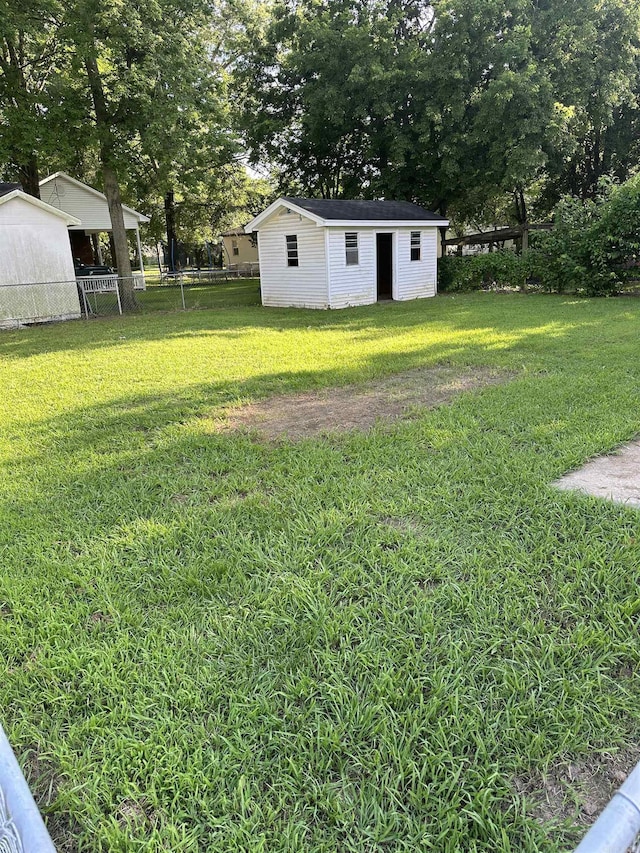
left=0, top=0, right=246, bottom=307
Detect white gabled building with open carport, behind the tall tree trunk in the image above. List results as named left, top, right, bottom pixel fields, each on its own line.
left=40, top=172, right=150, bottom=272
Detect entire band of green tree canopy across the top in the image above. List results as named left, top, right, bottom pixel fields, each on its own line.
left=0, top=0, right=640, bottom=239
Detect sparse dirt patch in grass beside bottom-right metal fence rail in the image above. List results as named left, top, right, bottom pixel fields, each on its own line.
left=515, top=747, right=640, bottom=827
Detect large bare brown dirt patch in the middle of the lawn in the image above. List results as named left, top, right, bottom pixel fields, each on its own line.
left=222, top=367, right=512, bottom=440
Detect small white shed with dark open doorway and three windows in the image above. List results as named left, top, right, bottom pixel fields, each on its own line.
left=245, top=197, right=449, bottom=308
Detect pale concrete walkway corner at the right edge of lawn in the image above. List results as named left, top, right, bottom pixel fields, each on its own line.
left=553, top=440, right=640, bottom=508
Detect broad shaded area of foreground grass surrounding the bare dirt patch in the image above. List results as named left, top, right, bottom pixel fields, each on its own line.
left=0, top=344, right=637, bottom=851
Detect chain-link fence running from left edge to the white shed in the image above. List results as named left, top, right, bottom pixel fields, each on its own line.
left=0, top=269, right=260, bottom=329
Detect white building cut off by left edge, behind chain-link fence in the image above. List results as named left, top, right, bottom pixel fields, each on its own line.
left=0, top=190, right=80, bottom=328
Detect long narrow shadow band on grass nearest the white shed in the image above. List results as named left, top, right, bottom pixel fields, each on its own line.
left=0, top=294, right=624, bottom=358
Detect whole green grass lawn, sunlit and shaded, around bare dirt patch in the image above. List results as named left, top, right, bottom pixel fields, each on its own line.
left=0, top=285, right=640, bottom=853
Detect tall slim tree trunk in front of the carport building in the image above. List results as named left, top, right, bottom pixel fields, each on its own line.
left=84, top=50, right=137, bottom=311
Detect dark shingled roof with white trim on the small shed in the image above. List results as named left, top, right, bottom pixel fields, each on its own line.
left=244, top=196, right=449, bottom=233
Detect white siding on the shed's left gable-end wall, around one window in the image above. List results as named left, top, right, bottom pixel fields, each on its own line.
left=258, top=213, right=328, bottom=308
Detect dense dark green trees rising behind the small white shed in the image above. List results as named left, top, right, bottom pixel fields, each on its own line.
left=238, top=0, right=638, bottom=224
